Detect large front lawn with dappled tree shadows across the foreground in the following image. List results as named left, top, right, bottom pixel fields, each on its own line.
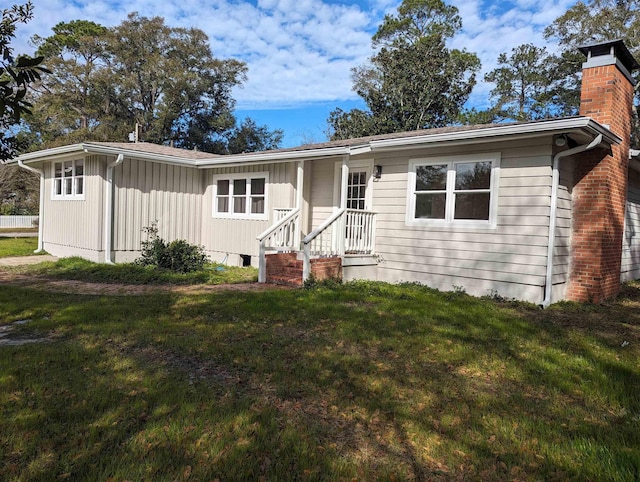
left=0, top=283, right=640, bottom=481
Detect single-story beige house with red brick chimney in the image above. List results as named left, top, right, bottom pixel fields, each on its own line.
left=10, top=41, right=640, bottom=305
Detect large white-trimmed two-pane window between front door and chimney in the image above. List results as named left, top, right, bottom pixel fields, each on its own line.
left=407, top=153, right=500, bottom=227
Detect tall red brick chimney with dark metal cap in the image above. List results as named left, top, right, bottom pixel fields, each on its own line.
left=567, top=40, right=639, bottom=303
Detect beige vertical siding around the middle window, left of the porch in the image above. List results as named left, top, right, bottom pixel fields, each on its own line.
left=201, top=162, right=297, bottom=266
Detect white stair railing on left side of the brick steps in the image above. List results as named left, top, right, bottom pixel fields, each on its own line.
left=257, top=208, right=300, bottom=283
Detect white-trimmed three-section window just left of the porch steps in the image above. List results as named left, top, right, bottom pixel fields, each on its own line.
left=213, top=172, right=269, bottom=219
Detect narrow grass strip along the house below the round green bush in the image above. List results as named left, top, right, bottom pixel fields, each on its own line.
left=16, top=257, right=258, bottom=285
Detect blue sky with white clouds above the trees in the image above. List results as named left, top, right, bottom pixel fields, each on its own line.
left=10, top=0, right=575, bottom=147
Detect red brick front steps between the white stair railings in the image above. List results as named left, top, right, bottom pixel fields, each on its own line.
left=266, top=253, right=342, bottom=287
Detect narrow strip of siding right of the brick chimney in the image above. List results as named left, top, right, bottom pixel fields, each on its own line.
left=620, top=171, right=640, bottom=282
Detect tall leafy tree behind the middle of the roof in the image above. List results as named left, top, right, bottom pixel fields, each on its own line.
left=328, top=0, right=480, bottom=139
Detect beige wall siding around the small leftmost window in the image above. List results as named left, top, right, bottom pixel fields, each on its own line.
left=41, top=155, right=106, bottom=262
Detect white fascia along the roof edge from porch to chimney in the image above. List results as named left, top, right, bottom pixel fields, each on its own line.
left=370, top=117, right=622, bottom=151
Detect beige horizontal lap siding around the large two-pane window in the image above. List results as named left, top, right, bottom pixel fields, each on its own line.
left=373, top=139, right=560, bottom=302
